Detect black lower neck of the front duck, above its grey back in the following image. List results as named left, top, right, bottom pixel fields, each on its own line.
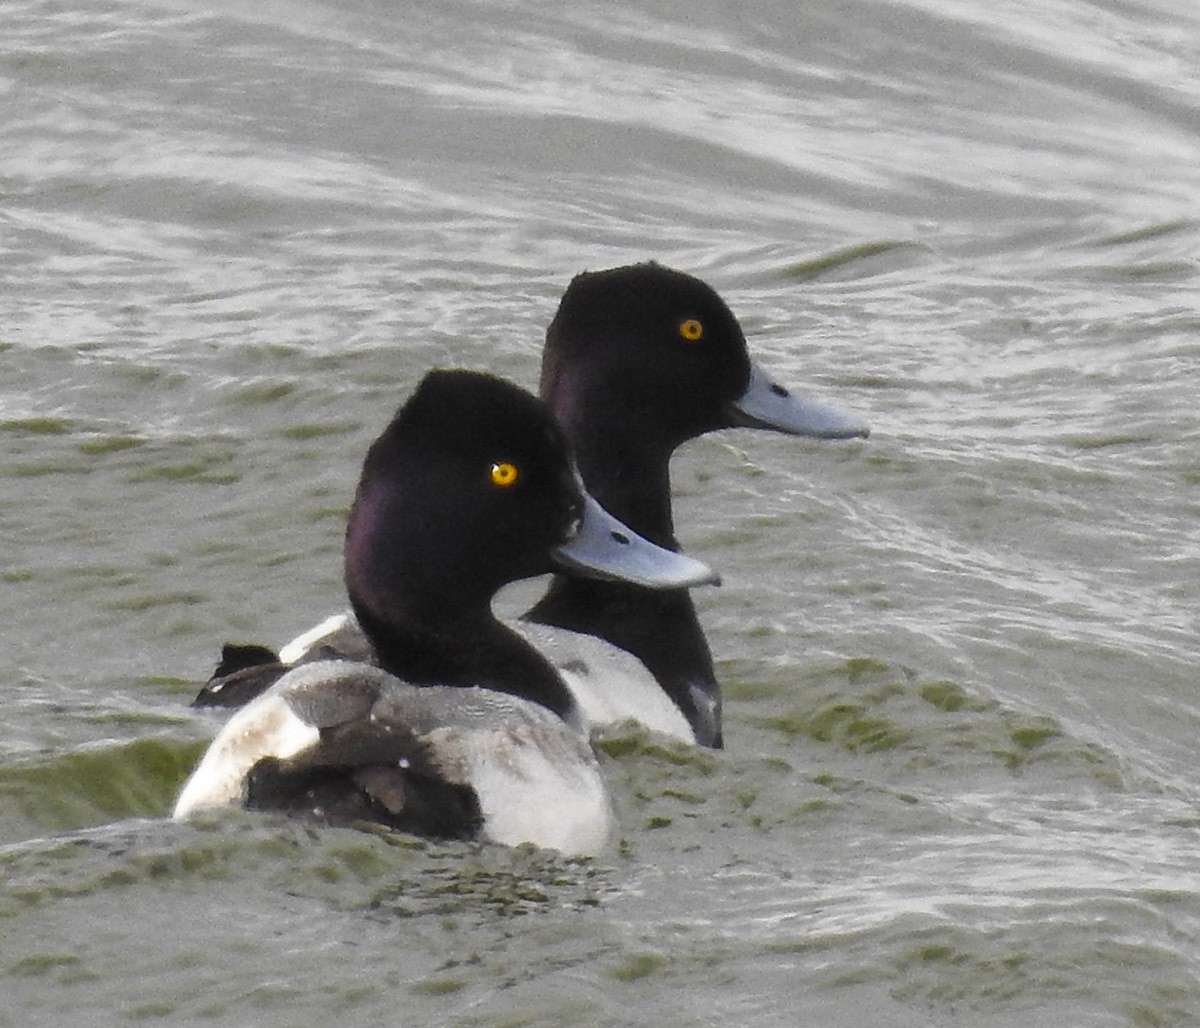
left=350, top=596, right=578, bottom=723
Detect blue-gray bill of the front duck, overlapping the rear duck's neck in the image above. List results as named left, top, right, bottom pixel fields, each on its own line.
left=552, top=497, right=721, bottom=589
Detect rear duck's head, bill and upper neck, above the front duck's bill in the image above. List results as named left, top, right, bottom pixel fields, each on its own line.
left=540, top=263, right=866, bottom=537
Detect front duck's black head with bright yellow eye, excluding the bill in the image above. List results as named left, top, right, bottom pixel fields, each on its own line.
left=346, top=371, right=583, bottom=619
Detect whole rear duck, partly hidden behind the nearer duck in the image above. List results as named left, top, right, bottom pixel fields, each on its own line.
left=194, top=261, right=870, bottom=749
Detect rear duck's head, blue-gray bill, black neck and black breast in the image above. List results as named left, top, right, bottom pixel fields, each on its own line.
left=526, top=264, right=868, bottom=746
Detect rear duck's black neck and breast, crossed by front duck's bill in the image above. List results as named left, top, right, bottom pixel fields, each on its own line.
left=526, top=388, right=721, bottom=746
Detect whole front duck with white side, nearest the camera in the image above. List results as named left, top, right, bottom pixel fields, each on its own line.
left=174, top=369, right=719, bottom=854
